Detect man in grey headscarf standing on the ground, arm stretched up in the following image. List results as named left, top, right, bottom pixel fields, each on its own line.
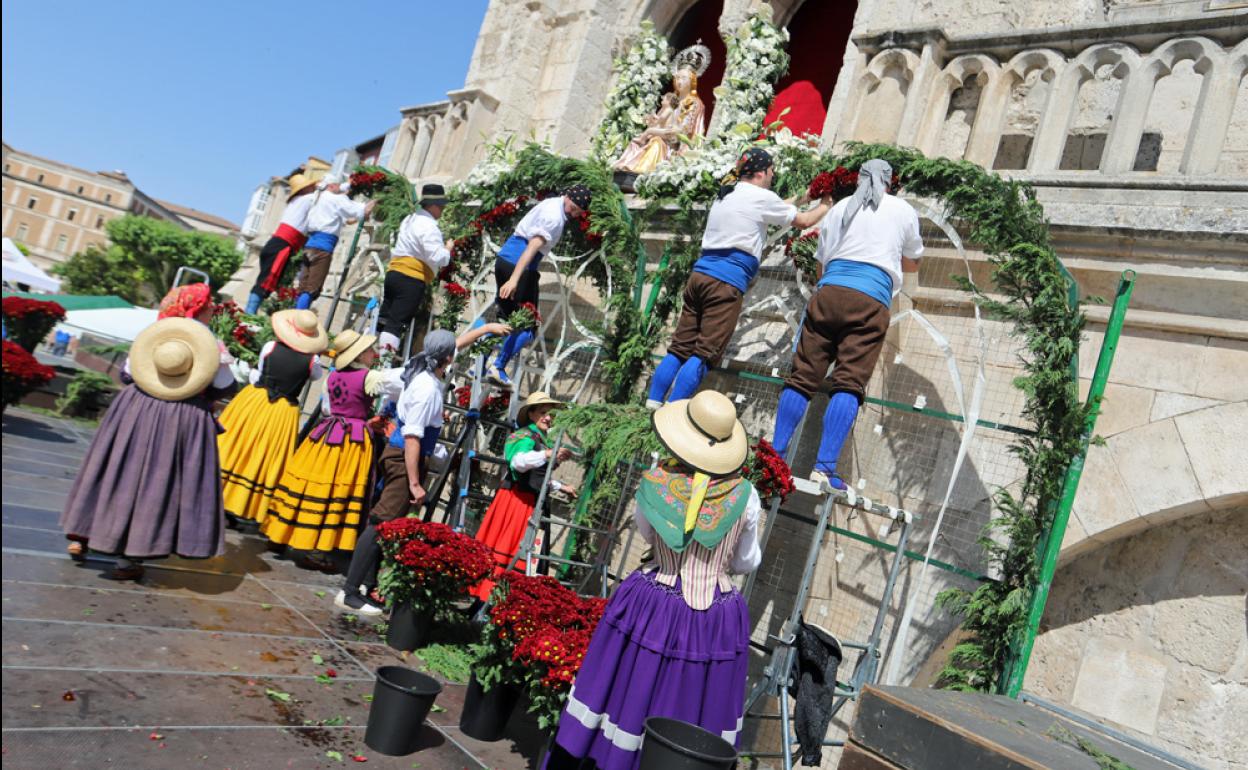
left=334, top=323, right=510, bottom=615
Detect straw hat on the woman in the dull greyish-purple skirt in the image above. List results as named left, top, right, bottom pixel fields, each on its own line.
left=130, top=318, right=221, bottom=401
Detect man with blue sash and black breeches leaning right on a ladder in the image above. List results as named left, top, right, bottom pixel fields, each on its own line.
left=487, top=185, right=593, bottom=388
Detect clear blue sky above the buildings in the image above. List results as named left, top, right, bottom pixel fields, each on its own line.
left=2, top=0, right=488, bottom=223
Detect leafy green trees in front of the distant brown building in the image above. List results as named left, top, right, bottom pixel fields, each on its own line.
left=55, top=215, right=242, bottom=303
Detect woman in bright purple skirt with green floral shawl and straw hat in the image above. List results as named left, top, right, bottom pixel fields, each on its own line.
left=547, top=391, right=763, bottom=770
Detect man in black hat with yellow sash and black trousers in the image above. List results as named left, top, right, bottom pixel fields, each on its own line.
left=377, top=185, right=451, bottom=351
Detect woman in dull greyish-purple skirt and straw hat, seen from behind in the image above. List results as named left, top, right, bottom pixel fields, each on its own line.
left=61, top=309, right=233, bottom=580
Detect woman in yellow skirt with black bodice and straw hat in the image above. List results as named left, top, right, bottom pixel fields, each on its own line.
left=217, top=309, right=328, bottom=532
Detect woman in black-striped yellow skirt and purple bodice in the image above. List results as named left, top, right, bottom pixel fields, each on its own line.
left=261, top=329, right=389, bottom=570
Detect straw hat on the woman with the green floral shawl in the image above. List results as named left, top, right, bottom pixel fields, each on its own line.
left=651, top=391, right=750, bottom=475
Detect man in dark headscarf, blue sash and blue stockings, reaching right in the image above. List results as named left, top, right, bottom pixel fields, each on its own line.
left=645, top=147, right=830, bottom=409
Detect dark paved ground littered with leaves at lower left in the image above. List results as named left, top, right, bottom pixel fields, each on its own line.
left=2, top=409, right=540, bottom=770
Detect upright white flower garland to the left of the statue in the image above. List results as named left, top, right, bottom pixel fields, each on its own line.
left=593, top=20, right=671, bottom=162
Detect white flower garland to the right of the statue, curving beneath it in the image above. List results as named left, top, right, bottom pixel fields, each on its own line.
left=636, top=11, right=789, bottom=198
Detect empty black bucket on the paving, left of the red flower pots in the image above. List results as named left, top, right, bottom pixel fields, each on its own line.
left=364, top=665, right=442, bottom=756
